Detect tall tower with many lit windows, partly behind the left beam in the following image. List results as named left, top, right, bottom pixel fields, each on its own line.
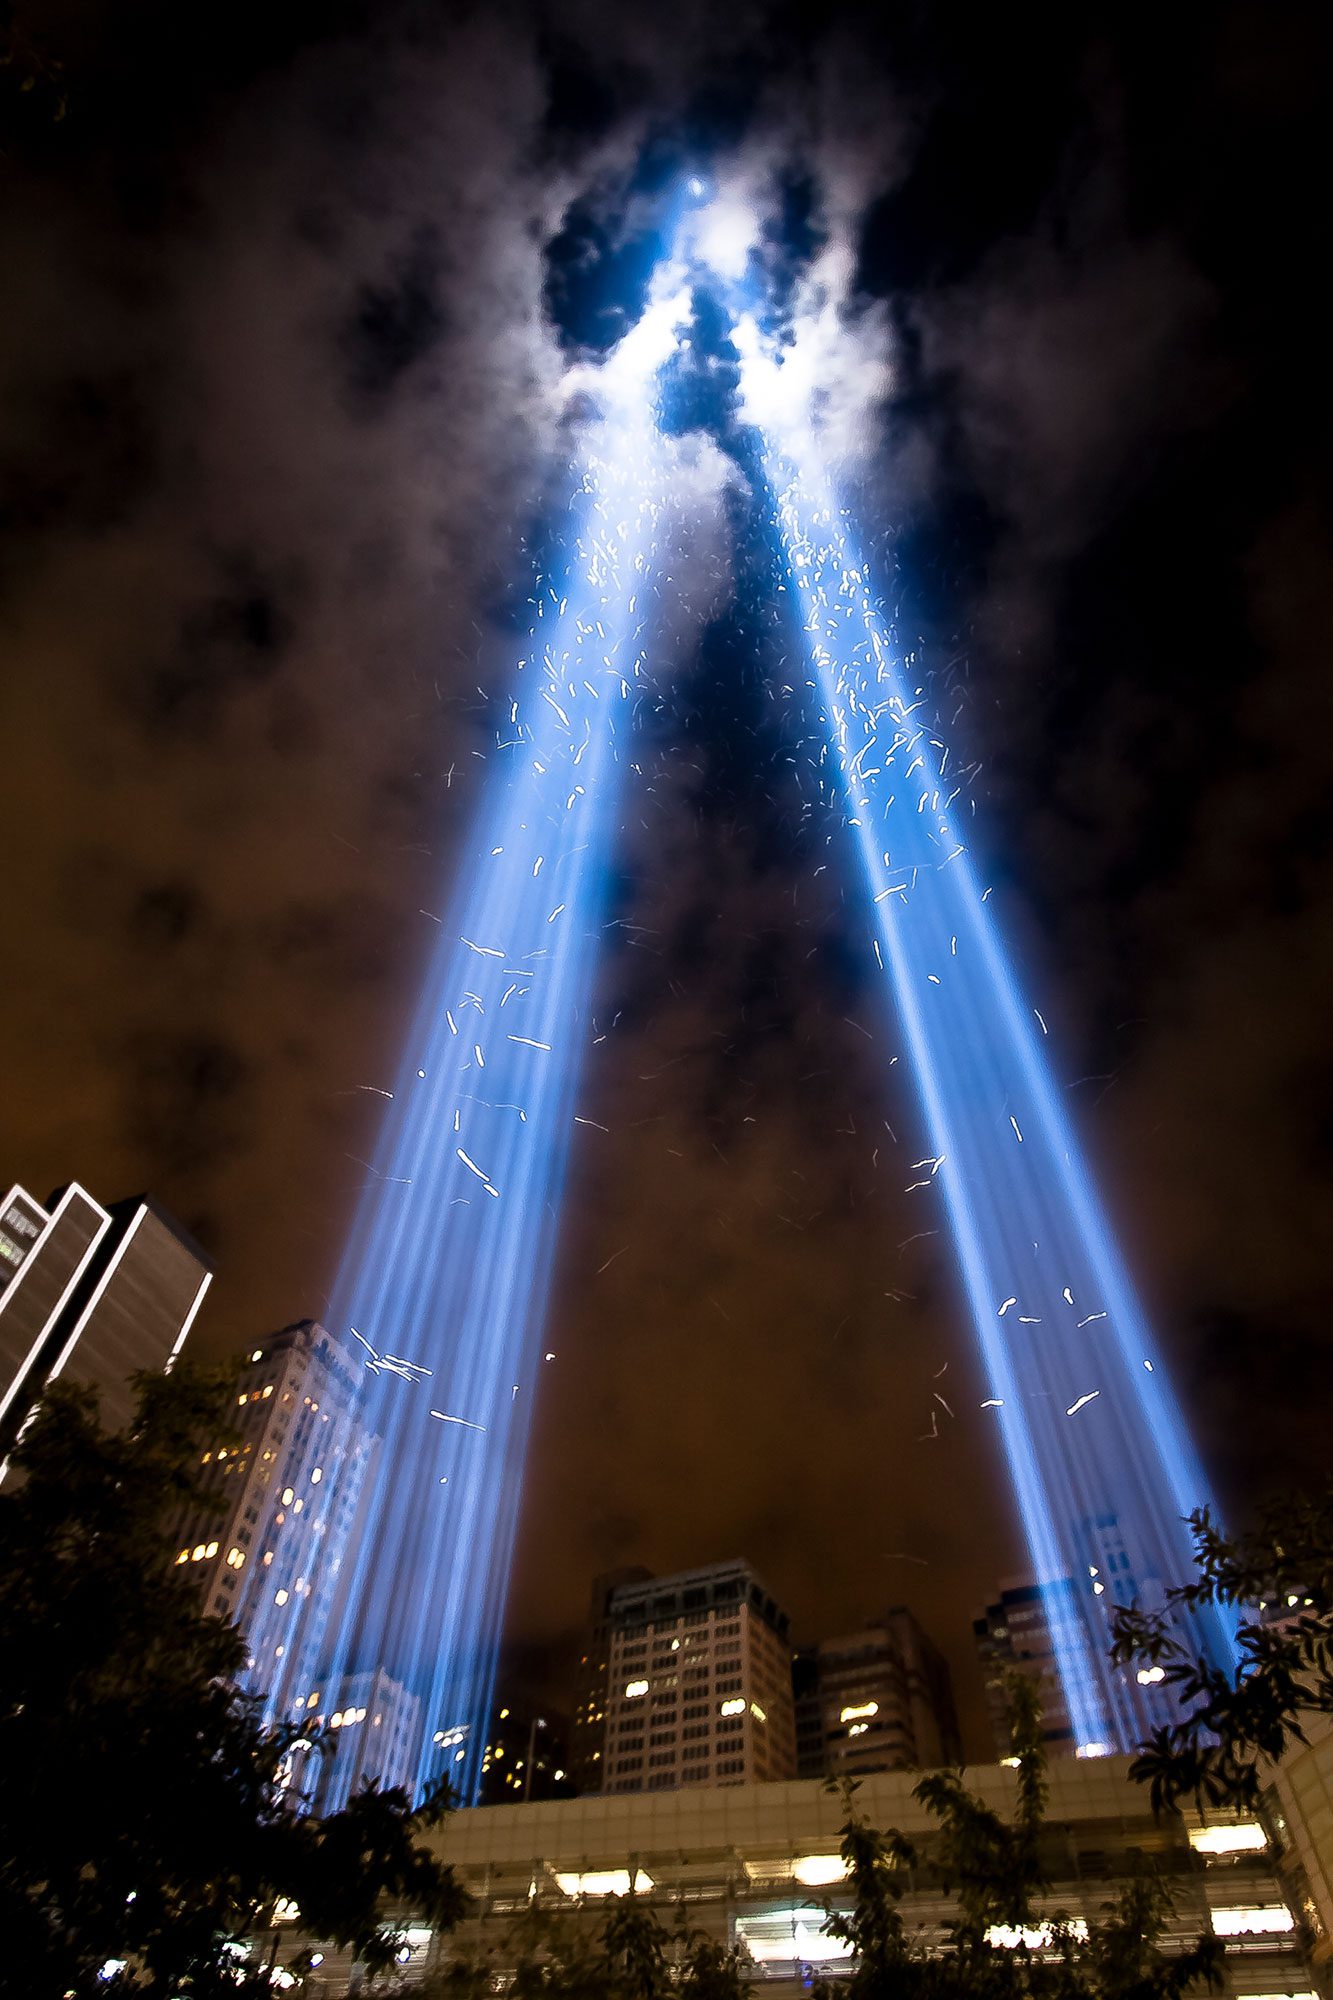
left=176, top=1320, right=378, bottom=1720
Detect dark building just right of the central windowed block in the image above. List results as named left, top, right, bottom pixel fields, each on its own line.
left=793, top=1606, right=963, bottom=1778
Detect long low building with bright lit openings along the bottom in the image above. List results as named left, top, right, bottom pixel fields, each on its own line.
left=282, top=1756, right=1333, bottom=2000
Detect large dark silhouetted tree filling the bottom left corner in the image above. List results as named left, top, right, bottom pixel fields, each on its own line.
left=0, top=1366, right=466, bottom=2000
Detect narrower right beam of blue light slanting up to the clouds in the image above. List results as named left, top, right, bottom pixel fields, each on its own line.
left=761, top=432, right=1237, bottom=1756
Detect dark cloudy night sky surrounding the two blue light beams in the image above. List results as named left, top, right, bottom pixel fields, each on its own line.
left=0, top=0, right=1333, bottom=1754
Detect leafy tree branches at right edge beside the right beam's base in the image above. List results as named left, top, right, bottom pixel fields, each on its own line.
left=1115, top=1488, right=1333, bottom=1810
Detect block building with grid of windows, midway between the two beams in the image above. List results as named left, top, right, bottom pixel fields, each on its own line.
left=602, top=1560, right=797, bottom=1792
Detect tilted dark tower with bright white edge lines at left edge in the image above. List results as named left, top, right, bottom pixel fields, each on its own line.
left=0, top=1182, right=212, bottom=1460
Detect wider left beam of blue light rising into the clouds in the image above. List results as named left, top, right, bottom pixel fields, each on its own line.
left=242, top=296, right=687, bottom=1806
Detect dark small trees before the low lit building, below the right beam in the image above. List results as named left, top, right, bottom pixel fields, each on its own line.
left=817, top=1676, right=1223, bottom=2000
